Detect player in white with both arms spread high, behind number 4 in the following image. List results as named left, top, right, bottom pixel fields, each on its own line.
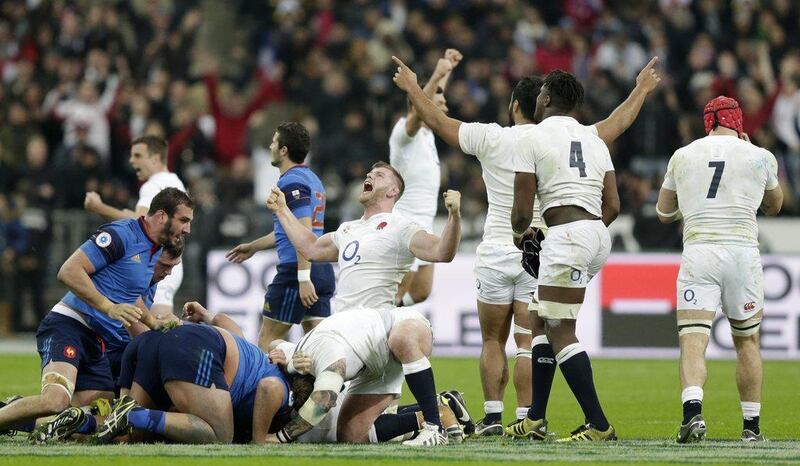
left=395, top=57, right=660, bottom=435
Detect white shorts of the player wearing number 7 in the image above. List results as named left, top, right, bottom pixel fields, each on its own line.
left=677, top=244, right=764, bottom=320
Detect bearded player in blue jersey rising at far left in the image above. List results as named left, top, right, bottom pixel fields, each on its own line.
left=0, top=188, right=194, bottom=431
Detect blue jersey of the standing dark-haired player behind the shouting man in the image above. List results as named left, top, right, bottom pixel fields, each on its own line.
left=272, top=165, right=326, bottom=264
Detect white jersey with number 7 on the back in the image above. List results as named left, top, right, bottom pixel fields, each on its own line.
left=663, top=136, right=778, bottom=247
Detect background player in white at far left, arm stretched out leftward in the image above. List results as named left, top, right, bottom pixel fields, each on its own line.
left=83, top=135, right=186, bottom=317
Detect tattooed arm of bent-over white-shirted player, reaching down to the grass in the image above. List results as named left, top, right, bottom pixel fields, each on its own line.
left=266, top=359, right=347, bottom=443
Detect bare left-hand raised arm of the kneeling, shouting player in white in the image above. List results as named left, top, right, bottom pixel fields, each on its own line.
left=267, top=187, right=339, bottom=262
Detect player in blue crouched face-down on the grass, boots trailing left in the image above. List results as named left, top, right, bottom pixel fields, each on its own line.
left=32, top=303, right=304, bottom=443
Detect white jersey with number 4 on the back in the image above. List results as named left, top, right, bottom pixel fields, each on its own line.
left=514, top=116, right=614, bottom=217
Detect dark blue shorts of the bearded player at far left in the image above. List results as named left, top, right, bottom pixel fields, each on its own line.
left=36, top=312, right=114, bottom=392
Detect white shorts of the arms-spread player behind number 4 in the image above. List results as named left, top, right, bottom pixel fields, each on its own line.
left=474, top=243, right=536, bottom=304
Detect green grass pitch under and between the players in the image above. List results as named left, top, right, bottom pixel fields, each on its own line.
left=0, top=355, right=800, bottom=466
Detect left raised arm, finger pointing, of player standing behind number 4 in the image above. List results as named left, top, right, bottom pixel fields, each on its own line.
left=392, top=57, right=461, bottom=147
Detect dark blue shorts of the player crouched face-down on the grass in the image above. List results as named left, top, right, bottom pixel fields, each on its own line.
left=158, top=323, right=229, bottom=390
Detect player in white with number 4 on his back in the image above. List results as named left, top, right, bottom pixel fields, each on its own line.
left=505, top=70, right=619, bottom=441
